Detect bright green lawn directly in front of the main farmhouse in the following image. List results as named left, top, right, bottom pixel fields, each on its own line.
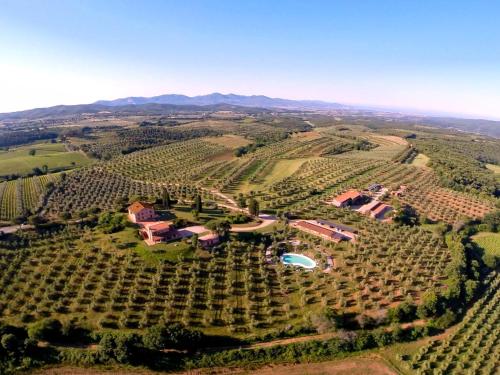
left=111, top=227, right=194, bottom=263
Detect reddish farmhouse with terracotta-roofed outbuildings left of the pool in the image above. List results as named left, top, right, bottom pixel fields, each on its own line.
left=128, top=202, right=220, bottom=248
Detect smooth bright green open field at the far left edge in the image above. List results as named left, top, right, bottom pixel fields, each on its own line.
left=0, top=143, right=92, bottom=176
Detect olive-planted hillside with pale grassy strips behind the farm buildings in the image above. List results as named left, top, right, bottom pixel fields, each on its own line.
left=43, top=130, right=494, bottom=223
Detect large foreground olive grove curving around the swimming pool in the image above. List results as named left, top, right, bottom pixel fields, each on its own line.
left=0, top=210, right=449, bottom=334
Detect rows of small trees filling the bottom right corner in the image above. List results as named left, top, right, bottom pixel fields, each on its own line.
left=403, top=276, right=500, bottom=375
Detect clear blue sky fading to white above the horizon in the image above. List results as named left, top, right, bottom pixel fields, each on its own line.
left=0, top=0, right=500, bottom=119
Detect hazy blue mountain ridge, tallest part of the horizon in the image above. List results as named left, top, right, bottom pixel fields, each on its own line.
left=94, top=92, right=349, bottom=110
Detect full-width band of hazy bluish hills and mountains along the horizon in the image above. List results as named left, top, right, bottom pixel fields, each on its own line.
left=0, top=93, right=500, bottom=138
